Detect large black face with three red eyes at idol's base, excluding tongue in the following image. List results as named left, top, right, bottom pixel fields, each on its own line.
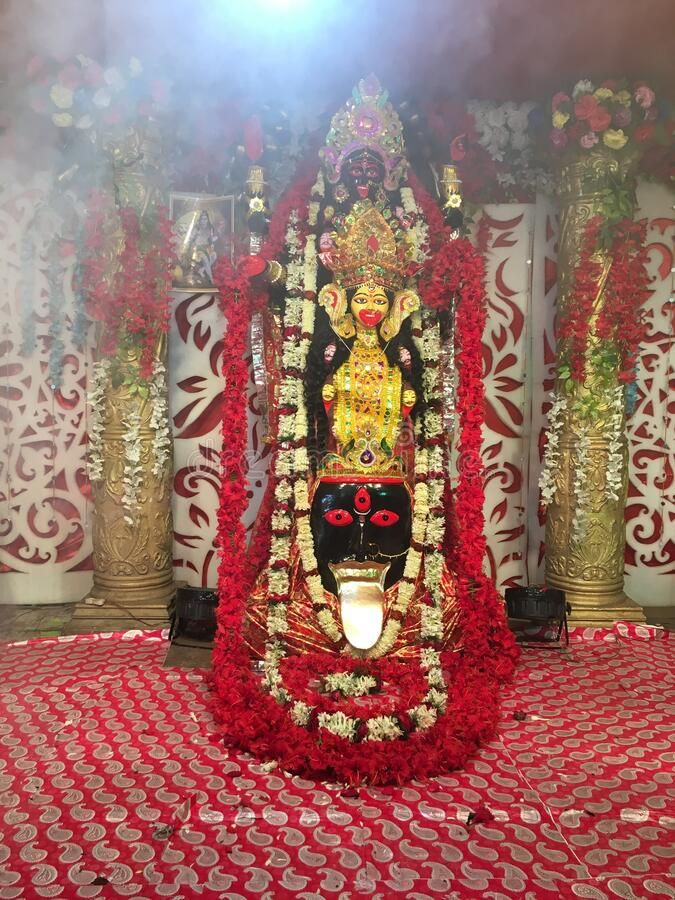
left=311, top=482, right=412, bottom=594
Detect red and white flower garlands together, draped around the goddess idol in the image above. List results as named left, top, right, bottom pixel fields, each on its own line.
left=212, top=163, right=515, bottom=783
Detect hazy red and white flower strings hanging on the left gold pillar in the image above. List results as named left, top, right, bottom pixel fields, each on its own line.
left=79, top=191, right=171, bottom=512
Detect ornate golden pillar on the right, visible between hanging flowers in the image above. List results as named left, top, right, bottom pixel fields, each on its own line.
left=546, top=151, right=645, bottom=626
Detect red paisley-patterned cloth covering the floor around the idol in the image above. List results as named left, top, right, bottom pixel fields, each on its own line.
left=0, top=626, right=675, bottom=900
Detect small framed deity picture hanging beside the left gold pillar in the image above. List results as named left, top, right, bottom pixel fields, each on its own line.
left=169, top=193, right=234, bottom=294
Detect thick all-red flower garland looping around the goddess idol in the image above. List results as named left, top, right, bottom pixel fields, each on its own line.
left=212, top=178, right=515, bottom=783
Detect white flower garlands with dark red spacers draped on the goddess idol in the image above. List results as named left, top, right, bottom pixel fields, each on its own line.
left=264, top=179, right=447, bottom=741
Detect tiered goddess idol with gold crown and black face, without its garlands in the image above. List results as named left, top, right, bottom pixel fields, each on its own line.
left=248, top=79, right=454, bottom=658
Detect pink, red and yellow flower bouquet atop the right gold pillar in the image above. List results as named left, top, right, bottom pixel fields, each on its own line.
left=549, top=79, right=672, bottom=153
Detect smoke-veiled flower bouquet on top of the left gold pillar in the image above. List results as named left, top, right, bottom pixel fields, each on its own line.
left=27, top=54, right=169, bottom=133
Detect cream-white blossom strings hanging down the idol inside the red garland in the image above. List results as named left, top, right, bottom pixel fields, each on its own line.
left=265, top=185, right=447, bottom=741
